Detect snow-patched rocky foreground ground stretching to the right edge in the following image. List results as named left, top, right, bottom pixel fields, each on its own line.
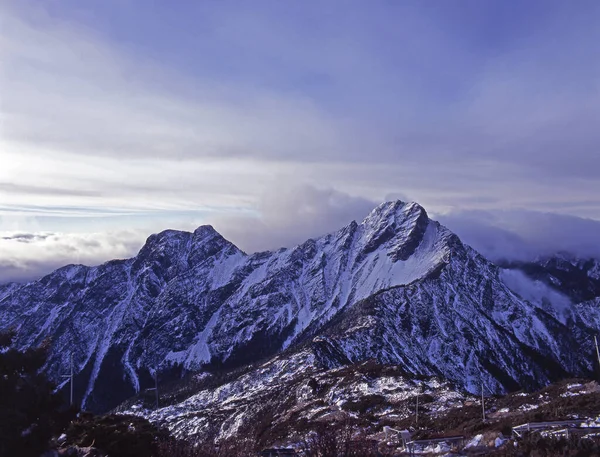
left=121, top=351, right=600, bottom=453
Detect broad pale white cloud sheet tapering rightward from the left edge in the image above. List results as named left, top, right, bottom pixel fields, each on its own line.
left=0, top=3, right=354, bottom=220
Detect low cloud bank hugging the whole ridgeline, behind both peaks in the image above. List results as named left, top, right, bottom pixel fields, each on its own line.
left=0, top=184, right=600, bottom=285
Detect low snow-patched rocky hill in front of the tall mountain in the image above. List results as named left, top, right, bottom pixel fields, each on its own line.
left=120, top=350, right=473, bottom=447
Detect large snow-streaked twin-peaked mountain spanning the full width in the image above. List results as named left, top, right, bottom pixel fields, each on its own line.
left=0, top=201, right=600, bottom=411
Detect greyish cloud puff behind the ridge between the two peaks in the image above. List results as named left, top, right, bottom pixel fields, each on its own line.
left=211, top=183, right=377, bottom=253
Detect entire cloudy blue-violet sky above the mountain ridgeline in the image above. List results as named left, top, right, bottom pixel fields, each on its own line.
left=0, top=0, right=600, bottom=283
